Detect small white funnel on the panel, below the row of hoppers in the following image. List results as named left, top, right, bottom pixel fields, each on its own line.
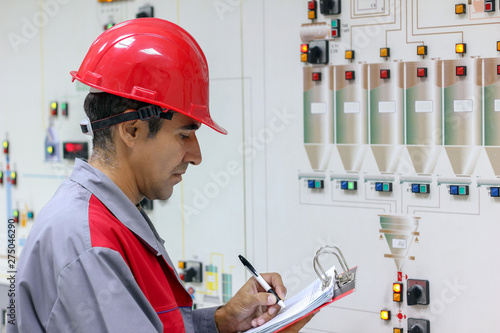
left=379, top=215, right=420, bottom=271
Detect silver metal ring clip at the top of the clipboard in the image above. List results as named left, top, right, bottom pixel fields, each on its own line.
left=313, top=245, right=357, bottom=294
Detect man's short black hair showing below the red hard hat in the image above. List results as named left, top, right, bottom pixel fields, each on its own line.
left=83, top=92, right=162, bottom=155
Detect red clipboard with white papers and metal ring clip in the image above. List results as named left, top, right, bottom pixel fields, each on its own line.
left=246, top=245, right=358, bottom=333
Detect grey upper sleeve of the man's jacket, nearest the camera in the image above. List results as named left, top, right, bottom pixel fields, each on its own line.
left=46, top=248, right=163, bottom=332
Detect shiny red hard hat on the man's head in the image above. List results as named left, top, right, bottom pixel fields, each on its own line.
left=71, top=18, right=227, bottom=134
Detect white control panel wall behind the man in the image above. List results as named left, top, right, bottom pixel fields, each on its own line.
left=0, top=0, right=500, bottom=333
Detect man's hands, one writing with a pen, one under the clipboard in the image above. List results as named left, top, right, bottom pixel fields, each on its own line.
left=215, top=273, right=288, bottom=333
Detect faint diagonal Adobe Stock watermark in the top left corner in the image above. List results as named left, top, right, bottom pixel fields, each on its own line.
left=7, top=0, right=71, bottom=53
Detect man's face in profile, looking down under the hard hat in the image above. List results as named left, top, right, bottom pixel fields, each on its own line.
left=132, top=113, right=201, bottom=200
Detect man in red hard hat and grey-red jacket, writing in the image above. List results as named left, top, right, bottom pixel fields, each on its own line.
left=8, top=18, right=311, bottom=333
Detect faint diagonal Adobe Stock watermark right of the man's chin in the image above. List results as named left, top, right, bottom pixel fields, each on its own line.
left=179, top=108, right=297, bottom=223
